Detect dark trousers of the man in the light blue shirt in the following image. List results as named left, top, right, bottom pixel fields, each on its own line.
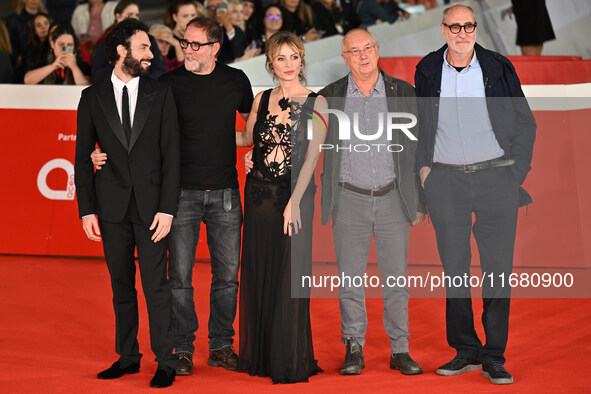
left=425, top=167, right=519, bottom=364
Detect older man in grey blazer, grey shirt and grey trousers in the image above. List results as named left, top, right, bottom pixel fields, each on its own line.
left=319, top=29, right=425, bottom=375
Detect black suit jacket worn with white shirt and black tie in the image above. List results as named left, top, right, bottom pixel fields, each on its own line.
left=75, top=77, right=180, bottom=224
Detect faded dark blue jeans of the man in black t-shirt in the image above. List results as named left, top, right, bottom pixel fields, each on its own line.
left=168, top=189, right=242, bottom=353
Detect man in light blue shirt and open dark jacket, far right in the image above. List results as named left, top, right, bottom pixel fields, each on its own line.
left=415, top=5, right=536, bottom=384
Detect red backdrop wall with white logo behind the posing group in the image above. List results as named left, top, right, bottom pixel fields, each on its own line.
left=0, top=58, right=591, bottom=267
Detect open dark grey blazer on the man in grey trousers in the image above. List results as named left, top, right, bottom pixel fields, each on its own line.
left=318, top=70, right=426, bottom=224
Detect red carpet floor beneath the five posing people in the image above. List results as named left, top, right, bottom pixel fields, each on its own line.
left=0, top=256, right=591, bottom=393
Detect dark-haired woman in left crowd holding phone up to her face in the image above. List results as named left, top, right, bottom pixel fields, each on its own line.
left=25, top=23, right=90, bottom=85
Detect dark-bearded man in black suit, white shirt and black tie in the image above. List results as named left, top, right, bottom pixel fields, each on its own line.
left=75, top=19, right=180, bottom=387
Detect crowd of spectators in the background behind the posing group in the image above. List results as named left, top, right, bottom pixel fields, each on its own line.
left=0, top=0, right=448, bottom=84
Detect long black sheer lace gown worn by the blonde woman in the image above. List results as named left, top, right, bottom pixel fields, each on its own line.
left=238, top=90, right=322, bottom=383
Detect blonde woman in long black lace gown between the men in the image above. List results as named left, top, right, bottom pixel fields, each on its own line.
left=237, top=32, right=326, bottom=383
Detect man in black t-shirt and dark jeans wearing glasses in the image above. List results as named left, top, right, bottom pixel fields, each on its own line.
left=160, top=17, right=253, bottom=375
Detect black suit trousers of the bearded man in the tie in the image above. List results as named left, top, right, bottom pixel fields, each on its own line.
left=99, top=193, right=178, bottom=369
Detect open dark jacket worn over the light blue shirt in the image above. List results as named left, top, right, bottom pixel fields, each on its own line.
left=415, top=44, right=536, bottom=206
